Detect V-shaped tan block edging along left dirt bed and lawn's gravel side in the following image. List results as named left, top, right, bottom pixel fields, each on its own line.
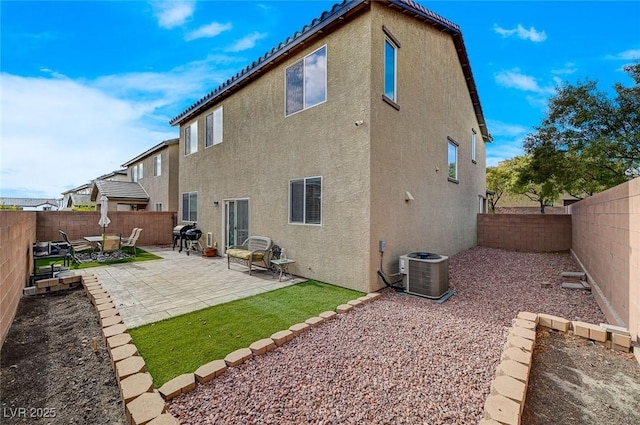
left=82, top=274, right=381, bottom=425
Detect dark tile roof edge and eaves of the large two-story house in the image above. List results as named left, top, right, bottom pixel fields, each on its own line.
left=169, top=0, right=492, bottom=142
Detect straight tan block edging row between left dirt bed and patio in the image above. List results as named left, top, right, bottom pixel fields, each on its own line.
left=82, top=274, right=178, bottom=425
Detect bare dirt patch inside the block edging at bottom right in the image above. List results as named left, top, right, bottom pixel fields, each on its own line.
left=522, top=330, right=640, bottom=425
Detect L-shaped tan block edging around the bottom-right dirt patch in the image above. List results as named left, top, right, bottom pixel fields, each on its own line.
left=478, top=311, right=631, bottom=425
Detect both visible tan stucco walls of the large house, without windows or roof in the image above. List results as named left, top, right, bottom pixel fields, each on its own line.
left=179, top=4, right=485, bottom=291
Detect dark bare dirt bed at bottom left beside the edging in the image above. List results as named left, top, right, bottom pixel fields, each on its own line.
left=0, top=289, right=126, bottom=425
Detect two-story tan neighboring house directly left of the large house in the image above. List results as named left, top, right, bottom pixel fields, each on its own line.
left=122, top=139, right=180, bottom=211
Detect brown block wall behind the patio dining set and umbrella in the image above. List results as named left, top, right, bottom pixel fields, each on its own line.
left=34, top=211, right=176, bottom=246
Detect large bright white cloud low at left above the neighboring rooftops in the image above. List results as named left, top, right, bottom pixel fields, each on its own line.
left=0, top=57, right=238, bottom=198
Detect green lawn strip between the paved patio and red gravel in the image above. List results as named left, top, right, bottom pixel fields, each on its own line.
left=129, top=280, right=363, bottom=387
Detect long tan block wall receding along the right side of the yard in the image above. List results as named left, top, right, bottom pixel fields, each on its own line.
left=569, top=178, right=640, bottom=341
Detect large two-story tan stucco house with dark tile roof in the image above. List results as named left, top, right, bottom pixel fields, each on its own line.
left=171, top=0, right=491, bottom=292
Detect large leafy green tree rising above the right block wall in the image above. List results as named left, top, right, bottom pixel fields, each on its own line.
left=521, top=63, right=640, bottom=198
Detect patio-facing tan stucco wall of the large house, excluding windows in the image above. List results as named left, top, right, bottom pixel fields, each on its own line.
left=179, top=12, right=370, bottom=291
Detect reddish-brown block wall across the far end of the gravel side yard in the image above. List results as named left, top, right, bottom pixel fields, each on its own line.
left=478, top=214, right=572, bottom=252
